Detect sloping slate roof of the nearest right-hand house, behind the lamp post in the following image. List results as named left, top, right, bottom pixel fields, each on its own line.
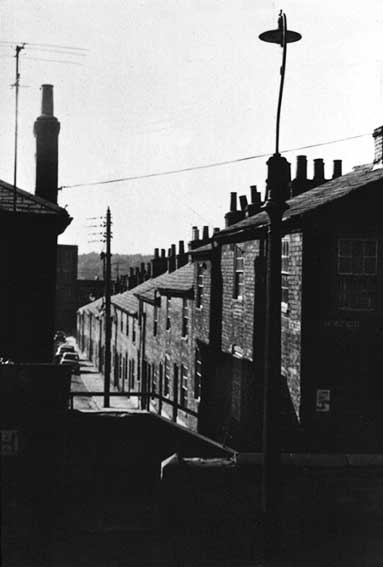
left=216, top=166, right=383, bottom=239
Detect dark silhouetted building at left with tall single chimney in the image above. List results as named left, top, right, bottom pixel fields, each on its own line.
left=0, top=85, right=71, bottom=362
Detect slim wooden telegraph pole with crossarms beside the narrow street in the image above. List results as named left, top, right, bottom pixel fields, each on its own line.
left=104, top=207, right=112, bottom=408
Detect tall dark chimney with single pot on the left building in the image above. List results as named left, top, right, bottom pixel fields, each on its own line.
left=33, top=85, right=60, bottom=203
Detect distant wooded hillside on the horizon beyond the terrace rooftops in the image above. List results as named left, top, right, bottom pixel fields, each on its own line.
left=78, top=252, right=152, bottom=280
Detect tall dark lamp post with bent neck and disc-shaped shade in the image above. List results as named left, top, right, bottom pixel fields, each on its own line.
left=259, top=11, right=301, bottom=561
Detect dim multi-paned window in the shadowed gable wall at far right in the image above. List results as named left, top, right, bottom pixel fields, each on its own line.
left=337, top=238, right=378, bottom=311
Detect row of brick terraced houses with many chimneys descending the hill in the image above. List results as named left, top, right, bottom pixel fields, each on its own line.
left=77, top=128, right=383, bottom=451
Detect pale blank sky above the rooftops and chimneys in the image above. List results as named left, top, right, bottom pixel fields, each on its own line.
left=0, top=0, right=383, bottom=253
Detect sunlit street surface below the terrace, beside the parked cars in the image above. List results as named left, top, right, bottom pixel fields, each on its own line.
left=67, top=337, right=140, bottom=411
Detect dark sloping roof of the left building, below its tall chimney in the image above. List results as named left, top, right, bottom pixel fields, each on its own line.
left=0, top=179, right=69, bottom=217
